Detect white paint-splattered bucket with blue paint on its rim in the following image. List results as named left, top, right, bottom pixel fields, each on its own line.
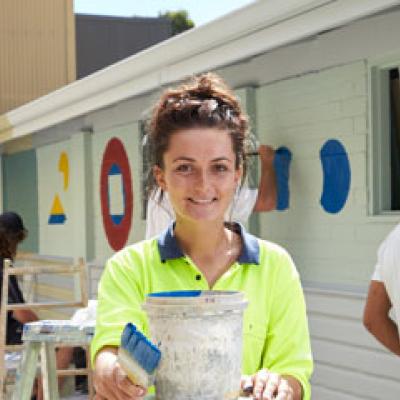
left=143, top=291, right=247, bottom=400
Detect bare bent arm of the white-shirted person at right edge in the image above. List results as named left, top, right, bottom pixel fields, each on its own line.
left=363, top=280, right=400, bottom=356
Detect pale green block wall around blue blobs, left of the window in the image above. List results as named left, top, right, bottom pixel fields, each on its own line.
left=256, top=61, right=393, bottom=287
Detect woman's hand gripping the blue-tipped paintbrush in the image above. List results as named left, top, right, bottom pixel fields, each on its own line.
left=94, top=347, right=147, bottom=400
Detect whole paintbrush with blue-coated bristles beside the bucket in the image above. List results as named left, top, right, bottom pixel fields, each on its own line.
left=118, top=323, right=161, bottom=388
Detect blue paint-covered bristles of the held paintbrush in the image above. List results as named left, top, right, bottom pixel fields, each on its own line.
left=121, top=323, right=161, bottom=375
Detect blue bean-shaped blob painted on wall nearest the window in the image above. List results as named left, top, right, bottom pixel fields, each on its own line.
left=320, top=139, right=351, bottom=214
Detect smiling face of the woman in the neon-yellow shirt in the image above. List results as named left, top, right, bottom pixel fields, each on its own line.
left=154, top=128, right=242, bottom=222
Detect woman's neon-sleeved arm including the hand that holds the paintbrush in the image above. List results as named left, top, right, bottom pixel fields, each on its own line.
left=91, top=247, right=152, bottom=400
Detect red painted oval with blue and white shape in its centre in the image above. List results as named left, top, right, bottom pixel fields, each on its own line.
left=100, top=137, right=133, bottom=250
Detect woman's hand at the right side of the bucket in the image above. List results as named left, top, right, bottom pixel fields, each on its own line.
left=241, top=369, right=301, bottom=400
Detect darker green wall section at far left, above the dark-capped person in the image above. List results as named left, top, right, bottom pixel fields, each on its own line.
left=2, top=150, right=39, bottom=252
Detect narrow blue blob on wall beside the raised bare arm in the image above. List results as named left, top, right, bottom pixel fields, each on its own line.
left=274, top=146, right=292, bottom=211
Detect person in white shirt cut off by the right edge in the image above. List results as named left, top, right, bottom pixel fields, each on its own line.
left=364, top=224, right=400, bottom=356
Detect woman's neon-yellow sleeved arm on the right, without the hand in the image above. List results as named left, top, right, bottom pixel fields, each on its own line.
left=263, top=252, right=313, bottom=400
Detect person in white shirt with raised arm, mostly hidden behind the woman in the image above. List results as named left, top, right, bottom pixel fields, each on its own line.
left=146, top=145, right=277, bottom=239
